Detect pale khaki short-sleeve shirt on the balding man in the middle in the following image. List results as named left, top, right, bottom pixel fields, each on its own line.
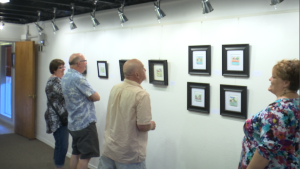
left=103, top=79, right=152, bottom=163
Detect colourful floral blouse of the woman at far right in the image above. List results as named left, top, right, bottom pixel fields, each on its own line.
left=239, top=98, right=300, bottom=169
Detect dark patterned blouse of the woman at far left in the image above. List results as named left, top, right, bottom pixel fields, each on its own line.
left=45, top=77, right=66, bottom=134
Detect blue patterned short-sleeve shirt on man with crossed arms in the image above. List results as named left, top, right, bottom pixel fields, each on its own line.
left=61, top=69, right=97, bottom=131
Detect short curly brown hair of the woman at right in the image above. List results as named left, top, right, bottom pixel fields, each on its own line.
left=273, top=59, right=299, bottom=91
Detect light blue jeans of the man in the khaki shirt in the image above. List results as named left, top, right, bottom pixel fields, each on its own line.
left=98, top=154, right=146, bottom=169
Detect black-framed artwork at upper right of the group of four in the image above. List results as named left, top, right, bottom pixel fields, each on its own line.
left=222, top=44, right=250, bottom=77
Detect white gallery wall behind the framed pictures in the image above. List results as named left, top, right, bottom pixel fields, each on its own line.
left=2, top=0, right=299, bottom=169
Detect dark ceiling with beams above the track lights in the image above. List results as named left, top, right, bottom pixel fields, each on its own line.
left=0, top=0, right=153, bottom=24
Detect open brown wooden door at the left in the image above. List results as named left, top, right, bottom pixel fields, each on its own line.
left=15, top=41, right=36, bottom=139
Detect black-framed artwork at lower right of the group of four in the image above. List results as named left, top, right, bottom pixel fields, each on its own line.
left=220, top=84, right=247, bottom=119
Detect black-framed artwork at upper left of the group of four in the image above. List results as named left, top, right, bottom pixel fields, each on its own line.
left=189, top=45, right=211, bottom=75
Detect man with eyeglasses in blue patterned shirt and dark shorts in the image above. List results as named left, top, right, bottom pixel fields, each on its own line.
left=61, top=53, right=100, bottom=169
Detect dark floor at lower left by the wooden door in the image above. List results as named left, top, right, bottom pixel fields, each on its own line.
left=0, top=121, right=70, bottom=169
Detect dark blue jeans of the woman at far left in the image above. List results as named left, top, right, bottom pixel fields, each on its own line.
left=53, top=126, right=69, bottom=168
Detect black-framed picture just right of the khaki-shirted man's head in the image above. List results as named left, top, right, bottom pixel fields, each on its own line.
left=149, top=60, right=168, bottom=85
